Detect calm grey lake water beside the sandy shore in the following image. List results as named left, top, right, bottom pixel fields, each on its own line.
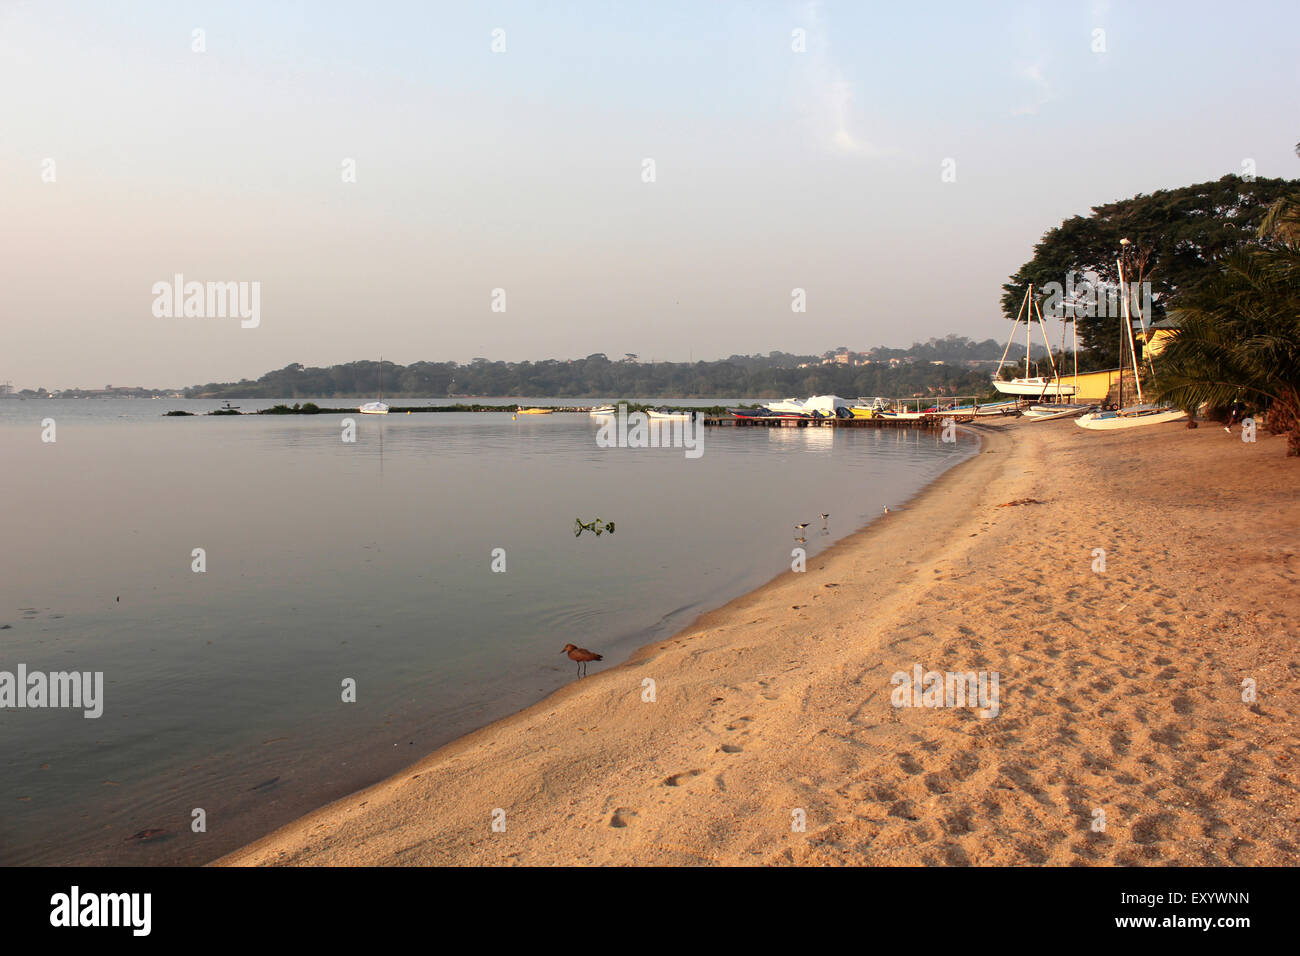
left=0, top=399, right=976, bottom=864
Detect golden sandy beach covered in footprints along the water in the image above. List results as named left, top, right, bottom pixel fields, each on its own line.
left=218, top=421, right=1300, bottom=865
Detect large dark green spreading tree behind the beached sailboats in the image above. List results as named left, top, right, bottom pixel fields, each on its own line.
left=1002, top=176, right=1300, bottom=368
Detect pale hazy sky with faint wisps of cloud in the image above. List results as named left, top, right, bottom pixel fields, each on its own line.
left=0, top=0, right=1300, bottom=389
